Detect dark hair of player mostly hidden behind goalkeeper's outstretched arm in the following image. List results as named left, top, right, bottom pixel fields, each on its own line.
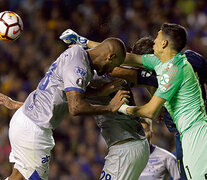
left=132, top=36, right=154, bottom=55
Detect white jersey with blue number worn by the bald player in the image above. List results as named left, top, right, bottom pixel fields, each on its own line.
left=23, top=46, right=93, bottom=128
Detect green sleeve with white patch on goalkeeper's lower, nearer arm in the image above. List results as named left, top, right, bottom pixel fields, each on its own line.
left=154, top=65, right=184, bottom=101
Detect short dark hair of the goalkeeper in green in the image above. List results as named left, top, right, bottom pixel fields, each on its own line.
left=161, top=23, right=187, bottom=52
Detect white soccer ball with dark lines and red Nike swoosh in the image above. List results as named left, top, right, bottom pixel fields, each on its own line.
left=0, top=11, right=23, bottom=41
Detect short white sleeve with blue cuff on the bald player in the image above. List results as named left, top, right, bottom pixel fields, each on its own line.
left=62, top=48, right=90, bottom=93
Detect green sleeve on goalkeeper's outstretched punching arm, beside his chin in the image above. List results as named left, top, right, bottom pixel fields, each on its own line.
left=141, top=54, right=161, bottom=70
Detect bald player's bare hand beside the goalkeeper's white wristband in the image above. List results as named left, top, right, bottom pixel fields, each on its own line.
left=108, top=90, right=130, bottom=112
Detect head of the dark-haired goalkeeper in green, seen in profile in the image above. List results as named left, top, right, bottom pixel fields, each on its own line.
left=154, top=23, right=187, bottom=56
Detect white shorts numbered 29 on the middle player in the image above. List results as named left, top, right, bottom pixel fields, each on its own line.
left=100, top=139, right=149, bottom=180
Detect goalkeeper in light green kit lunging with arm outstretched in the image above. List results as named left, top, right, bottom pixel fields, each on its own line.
left=119, top=23, right=207, bottom=180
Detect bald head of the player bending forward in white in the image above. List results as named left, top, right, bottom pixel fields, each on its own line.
left=88, top=38, right=126, bottom=75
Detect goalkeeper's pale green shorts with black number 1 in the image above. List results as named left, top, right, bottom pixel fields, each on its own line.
left=182, top=121, right=207, bottom=180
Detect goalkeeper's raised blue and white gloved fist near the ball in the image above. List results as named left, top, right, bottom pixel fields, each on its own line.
left=59, top=29, right=88, bottom=46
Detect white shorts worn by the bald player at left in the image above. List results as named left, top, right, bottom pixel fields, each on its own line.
left=9, top=108, right=55, bottom=180
